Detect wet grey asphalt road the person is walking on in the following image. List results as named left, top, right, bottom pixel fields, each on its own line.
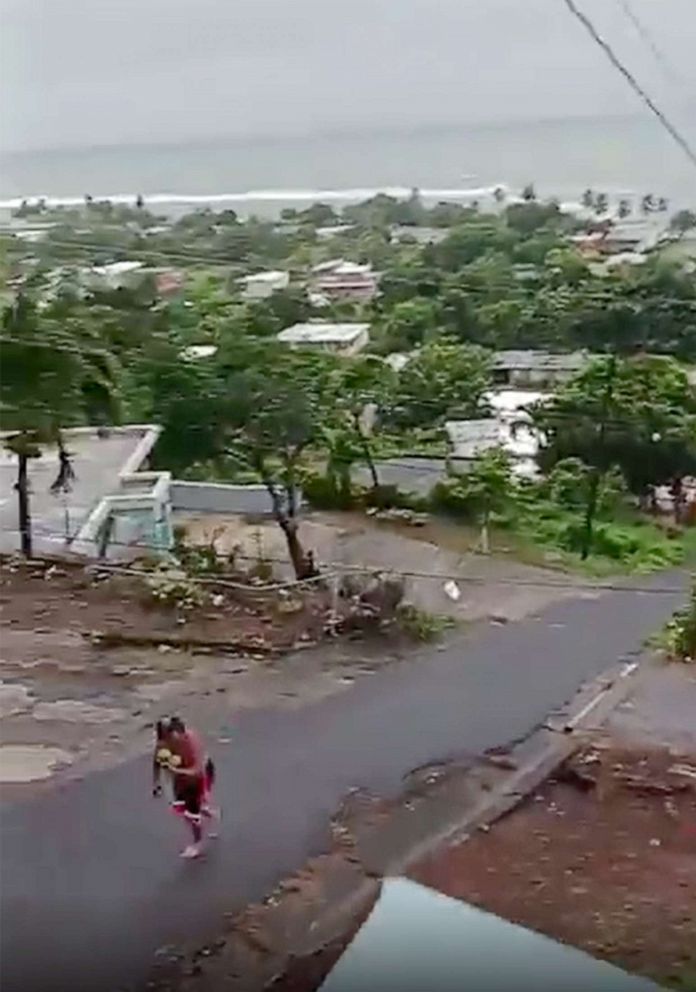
left=0, top=575, right=685, bottom=992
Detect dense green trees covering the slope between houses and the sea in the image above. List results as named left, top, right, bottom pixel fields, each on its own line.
left=0, top=188, right=696, bottom=574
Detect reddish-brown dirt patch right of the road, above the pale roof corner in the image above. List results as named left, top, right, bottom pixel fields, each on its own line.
left=411, top=740, right=696, bottom=990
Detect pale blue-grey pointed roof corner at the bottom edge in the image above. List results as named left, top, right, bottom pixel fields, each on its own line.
left=321, top=878, right=658, bottom=992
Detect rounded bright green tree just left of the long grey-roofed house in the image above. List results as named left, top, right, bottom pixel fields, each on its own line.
left=388, top=340, right=491, bottom=428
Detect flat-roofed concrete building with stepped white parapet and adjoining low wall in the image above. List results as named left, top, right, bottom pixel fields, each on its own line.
left=0, top=424, right=302, bottom=560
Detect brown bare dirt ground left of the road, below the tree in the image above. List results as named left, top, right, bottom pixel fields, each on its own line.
left=0, top=564, right=402, bottom=800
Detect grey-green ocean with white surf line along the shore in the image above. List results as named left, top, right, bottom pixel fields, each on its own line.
left=0, top=116, right=696, bottom=216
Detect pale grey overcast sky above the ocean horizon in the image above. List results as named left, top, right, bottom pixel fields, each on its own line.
left=0, top=0, right=696, bottom=151
